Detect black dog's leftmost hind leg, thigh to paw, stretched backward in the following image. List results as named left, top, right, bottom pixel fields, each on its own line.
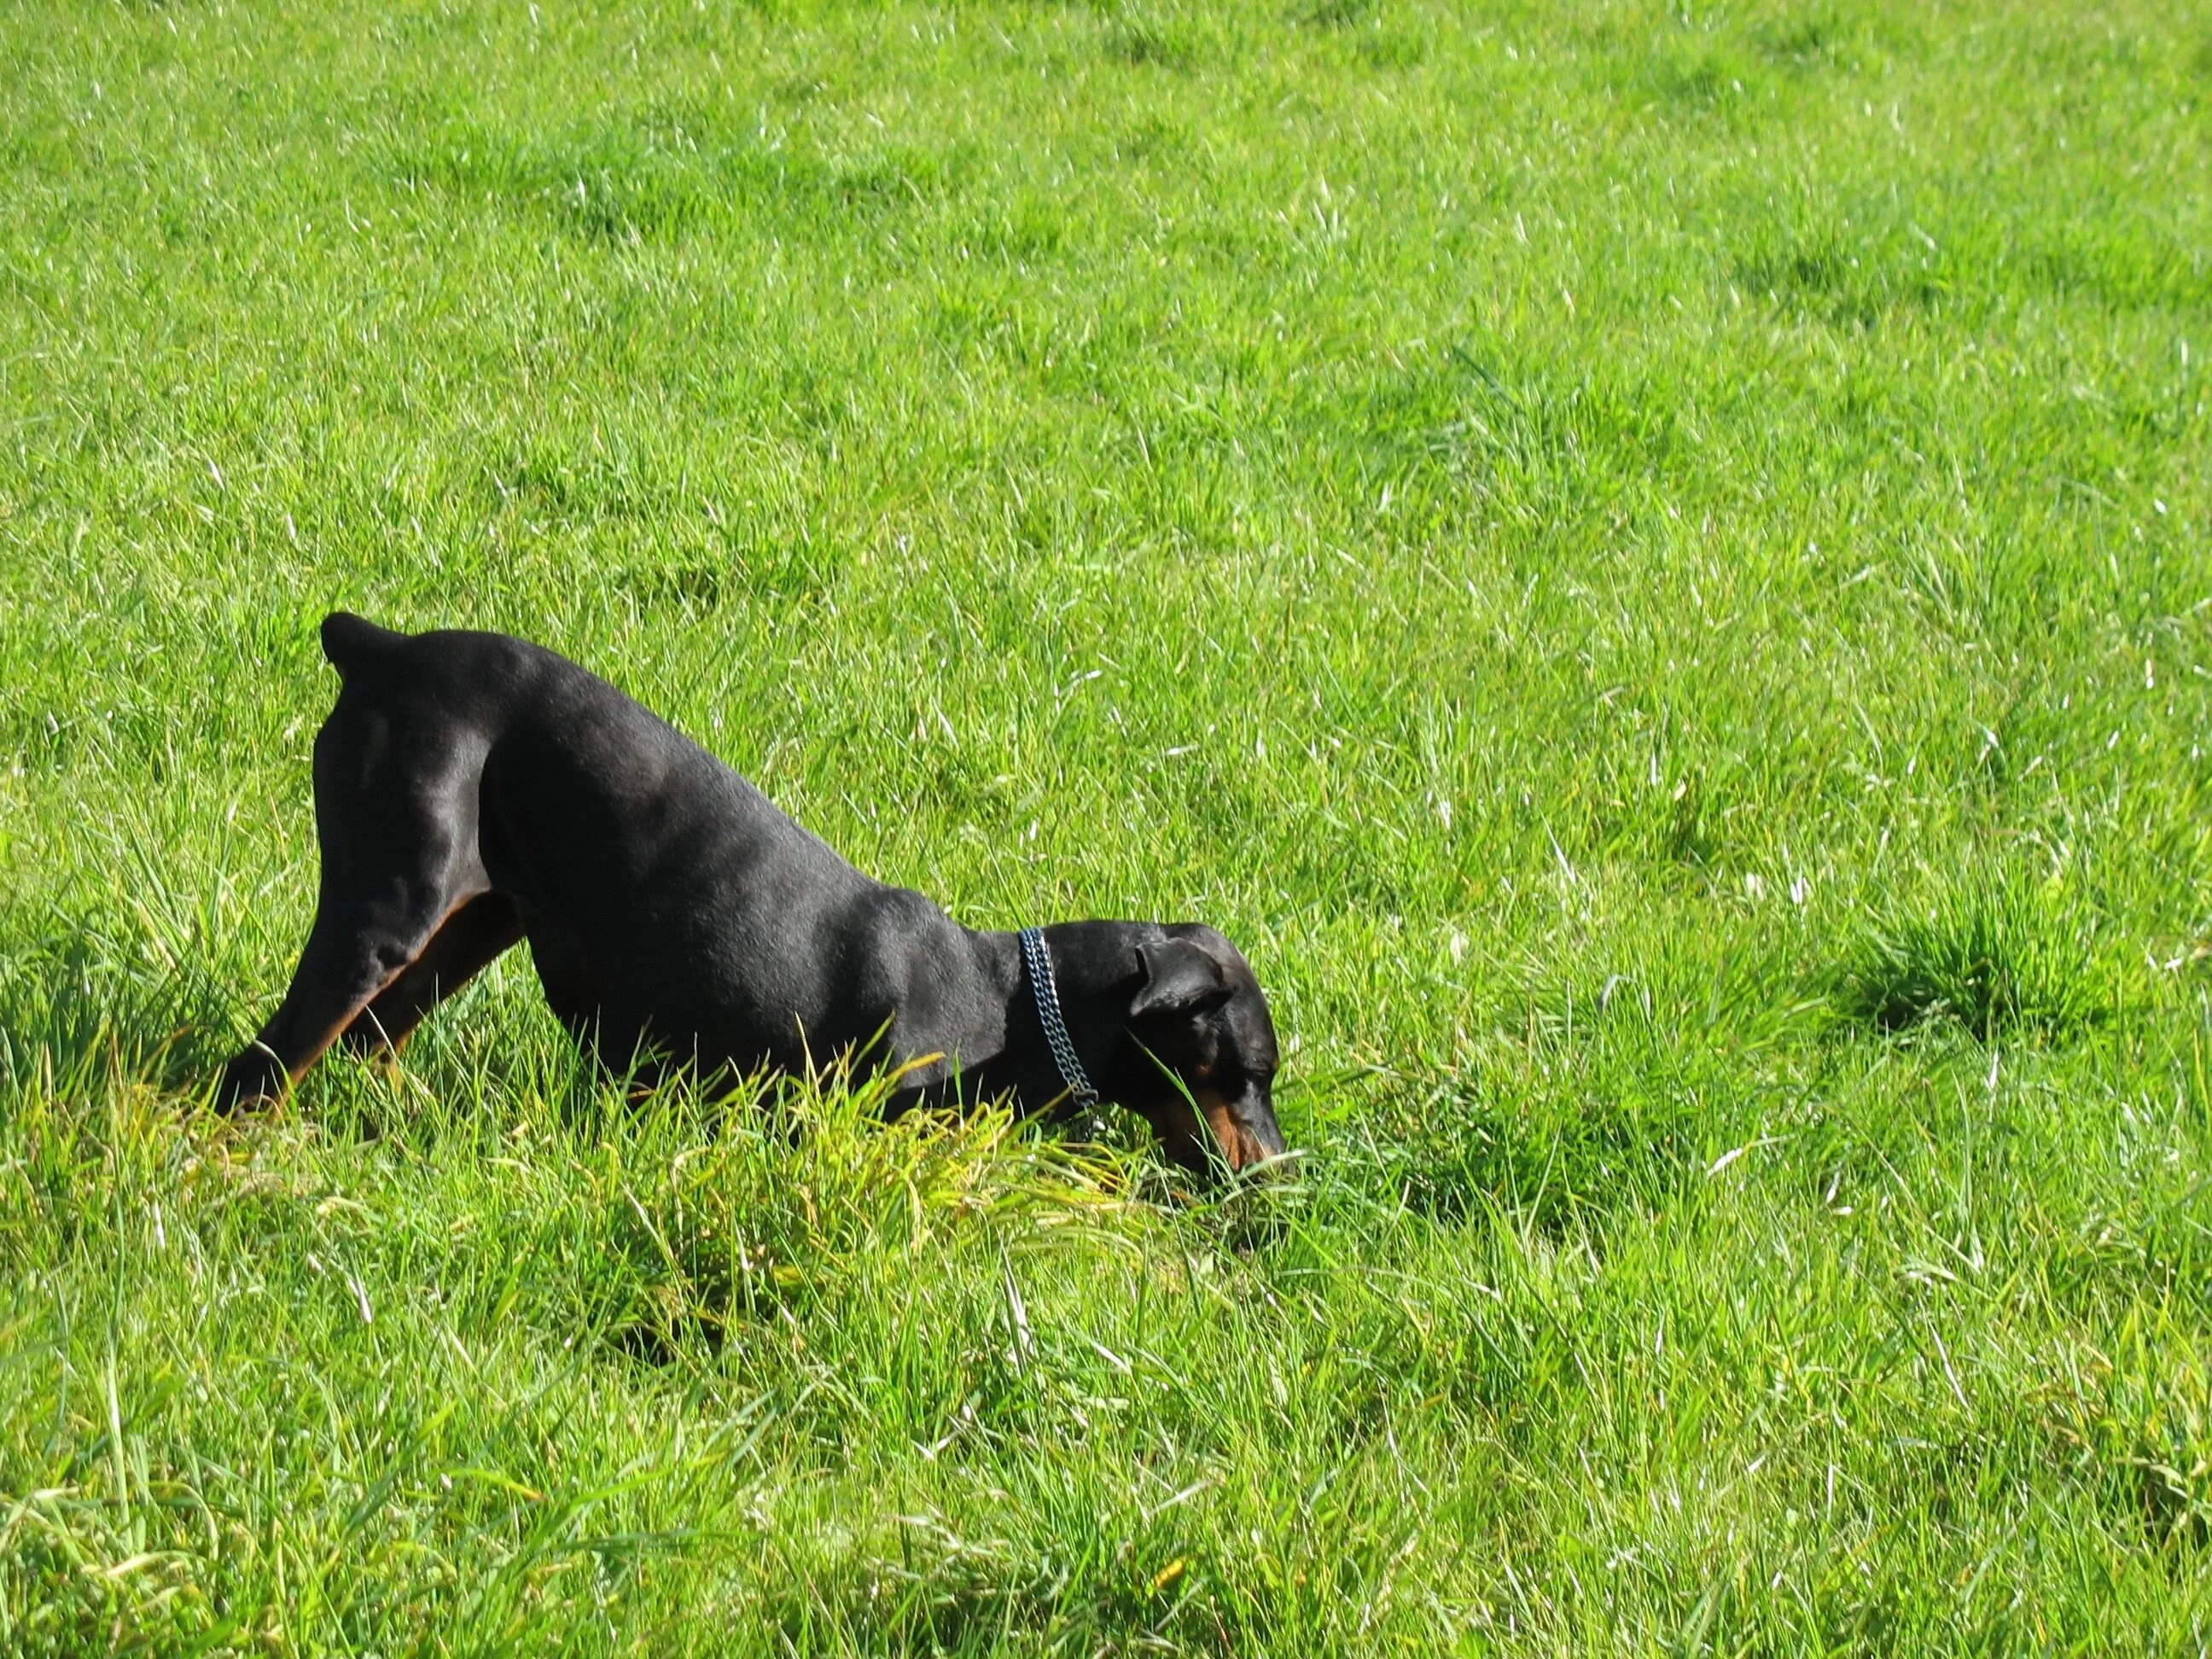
left=217, top=684, right=491, bottom=1109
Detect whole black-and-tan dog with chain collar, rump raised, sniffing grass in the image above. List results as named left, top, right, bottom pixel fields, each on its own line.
left=217, top=610, right=1283, bottom=1170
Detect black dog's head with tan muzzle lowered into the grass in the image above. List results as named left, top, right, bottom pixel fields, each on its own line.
left=1103, top=924, right=1285, bottom=1173
